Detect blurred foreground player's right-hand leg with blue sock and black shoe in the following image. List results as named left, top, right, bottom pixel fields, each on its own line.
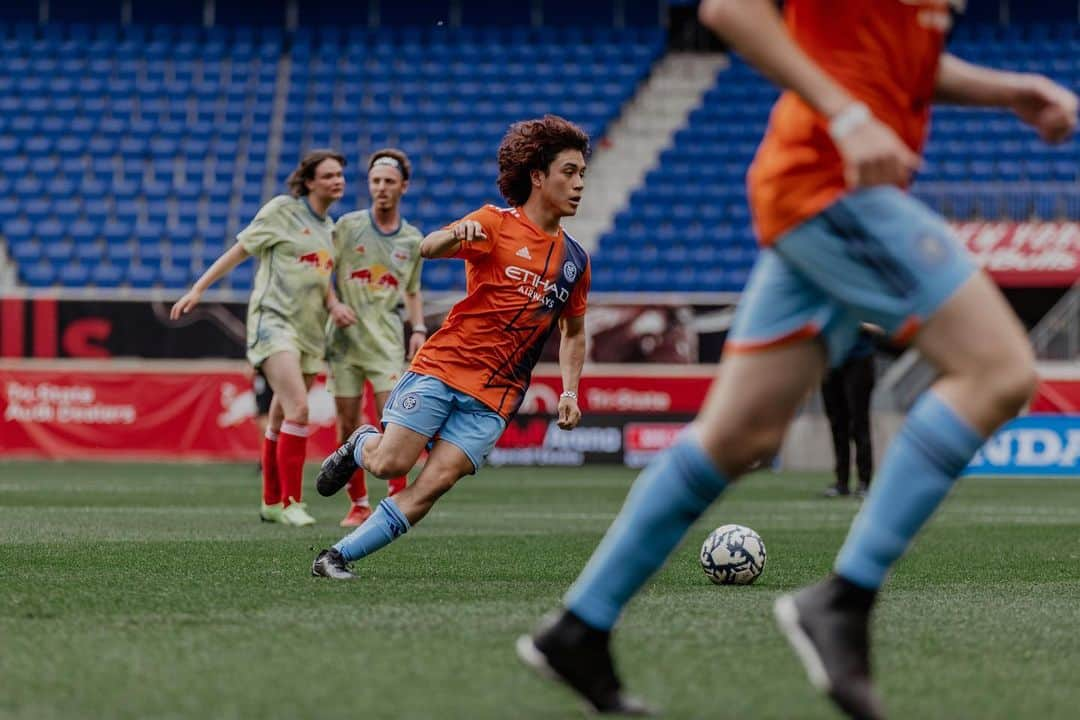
left=775, top=273, right=1036, bottom=718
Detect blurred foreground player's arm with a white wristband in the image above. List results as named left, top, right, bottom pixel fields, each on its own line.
left=698, top=0, right=920, bottom=188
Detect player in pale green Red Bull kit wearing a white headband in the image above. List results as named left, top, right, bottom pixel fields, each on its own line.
left=326, top=148, right=428, bottom=527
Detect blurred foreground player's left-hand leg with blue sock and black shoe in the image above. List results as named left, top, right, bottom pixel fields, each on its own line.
left=517, top=340, right=825, bottom=715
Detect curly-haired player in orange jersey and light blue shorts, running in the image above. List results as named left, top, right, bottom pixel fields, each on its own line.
left=311, top=116, right=590, bottom=580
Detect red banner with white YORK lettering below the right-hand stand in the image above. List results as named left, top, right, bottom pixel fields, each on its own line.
left=953, top=222, right=1080, bottom=287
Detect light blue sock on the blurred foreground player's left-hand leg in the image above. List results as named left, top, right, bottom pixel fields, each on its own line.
left=564, top=434, right=728, bottom=630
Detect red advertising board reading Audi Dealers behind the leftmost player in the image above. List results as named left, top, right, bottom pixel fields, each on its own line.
left=0, top=367, right=337, bottom=460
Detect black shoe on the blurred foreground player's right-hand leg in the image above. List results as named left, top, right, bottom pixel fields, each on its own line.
left=773, top=575, right=886, bottom=720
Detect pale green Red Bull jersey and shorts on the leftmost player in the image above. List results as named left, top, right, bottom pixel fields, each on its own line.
left=237, top=195, right=335, bottom=358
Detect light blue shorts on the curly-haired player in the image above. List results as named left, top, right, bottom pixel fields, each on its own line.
left=382, top=372, right=507, bottom=473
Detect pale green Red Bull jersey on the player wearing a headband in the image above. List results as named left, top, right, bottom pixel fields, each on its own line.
left=326, top=210, right=423, bottom=371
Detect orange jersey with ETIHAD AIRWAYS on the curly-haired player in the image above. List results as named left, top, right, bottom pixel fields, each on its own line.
left=410, top=205, right=591, bottom=419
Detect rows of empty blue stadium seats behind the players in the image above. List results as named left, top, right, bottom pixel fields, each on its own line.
left=0, top=24, right=1080, bottom=291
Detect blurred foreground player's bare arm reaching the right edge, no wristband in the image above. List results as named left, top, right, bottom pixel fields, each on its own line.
left=934, top=53, right=1077, bottom=142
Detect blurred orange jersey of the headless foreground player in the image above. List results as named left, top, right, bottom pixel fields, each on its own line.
left=746, top=0, right=951, bottom=245
